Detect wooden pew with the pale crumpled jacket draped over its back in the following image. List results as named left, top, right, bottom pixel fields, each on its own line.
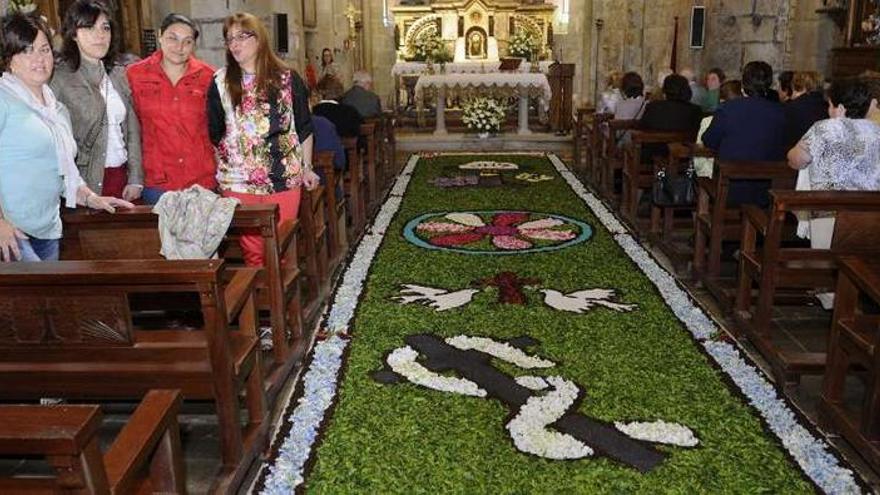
left=61, top=204, right=307, bottom=402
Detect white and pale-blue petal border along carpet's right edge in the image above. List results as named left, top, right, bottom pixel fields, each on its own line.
left=547, top=153, right=862, bottom=494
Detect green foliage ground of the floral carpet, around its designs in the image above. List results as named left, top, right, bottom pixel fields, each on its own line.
left=306, top=156, right=813, bottom=494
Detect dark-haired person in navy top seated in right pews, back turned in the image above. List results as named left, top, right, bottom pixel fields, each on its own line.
left=703, top=61, right=786, bottom=207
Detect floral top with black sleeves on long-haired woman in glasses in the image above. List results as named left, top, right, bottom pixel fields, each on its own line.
left=208, top=68, right=313, bottom=195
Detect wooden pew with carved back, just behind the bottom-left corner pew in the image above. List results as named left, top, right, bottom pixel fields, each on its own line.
left=0, top=260, right=268, bottom=493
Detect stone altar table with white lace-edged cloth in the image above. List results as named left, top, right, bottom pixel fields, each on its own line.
left=415, top=72, right=551, bottom=135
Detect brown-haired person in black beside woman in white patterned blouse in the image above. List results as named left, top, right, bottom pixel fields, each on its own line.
left=785, top=71, right=828, bottom=148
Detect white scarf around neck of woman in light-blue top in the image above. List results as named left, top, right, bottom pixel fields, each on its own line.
left=0, top=72, right=85, bottom=208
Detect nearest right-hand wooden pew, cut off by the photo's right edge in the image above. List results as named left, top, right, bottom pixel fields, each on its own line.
left=819, top=256, right=880, bottom=470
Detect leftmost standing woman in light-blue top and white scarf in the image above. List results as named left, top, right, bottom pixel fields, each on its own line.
left=0, top=14, right=133, bottom=262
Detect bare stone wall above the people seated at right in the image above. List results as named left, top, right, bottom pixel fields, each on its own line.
left=584, top=0, right=842, bottom=101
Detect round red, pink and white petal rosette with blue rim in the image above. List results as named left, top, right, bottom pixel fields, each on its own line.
left=404, top=211, right=592, bottom=254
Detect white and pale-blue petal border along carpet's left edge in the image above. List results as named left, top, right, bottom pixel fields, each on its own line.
left=257, top=155, right=419, bottom=495
